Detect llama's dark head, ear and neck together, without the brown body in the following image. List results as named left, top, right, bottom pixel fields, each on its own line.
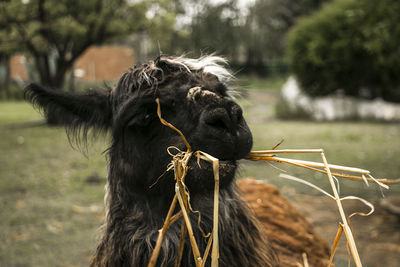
left=26, top=56, right=330, bottom=267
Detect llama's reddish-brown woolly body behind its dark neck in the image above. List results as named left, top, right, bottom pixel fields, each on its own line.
left=237, top=179, right=330, bottom=267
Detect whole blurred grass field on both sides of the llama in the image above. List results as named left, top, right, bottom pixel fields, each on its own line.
left=0, top=87, right=400, bottom=267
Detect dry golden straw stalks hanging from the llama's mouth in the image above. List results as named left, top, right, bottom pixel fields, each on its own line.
left=148, top=99, right=400, bottom=267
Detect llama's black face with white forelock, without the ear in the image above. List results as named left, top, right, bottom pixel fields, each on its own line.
left=111, top=58, right=252, bottom=195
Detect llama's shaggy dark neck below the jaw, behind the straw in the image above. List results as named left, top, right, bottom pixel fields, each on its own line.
left=93, top=151, right=276, bottom=267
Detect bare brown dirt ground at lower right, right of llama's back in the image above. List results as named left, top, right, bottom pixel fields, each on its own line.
left=282, top=191, right=400, bottom=267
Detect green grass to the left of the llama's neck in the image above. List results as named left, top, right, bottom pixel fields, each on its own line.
left=0, top=102, right=106, bottom=266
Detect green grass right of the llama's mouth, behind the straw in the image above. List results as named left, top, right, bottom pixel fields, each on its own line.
left=241, top=120, right=400, bottom=198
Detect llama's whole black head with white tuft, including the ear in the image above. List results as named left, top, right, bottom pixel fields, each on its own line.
left=26, top=56, right=252, bottom=196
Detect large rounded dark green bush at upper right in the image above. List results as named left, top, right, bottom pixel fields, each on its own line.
left=288, top=0, right=400, bottom=102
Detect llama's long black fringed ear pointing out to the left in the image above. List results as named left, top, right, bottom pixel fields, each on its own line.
left=25, top=84, right=112, bottom=132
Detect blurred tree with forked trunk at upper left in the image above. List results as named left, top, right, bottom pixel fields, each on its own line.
left=0, top=0, right=148, bottom=88
